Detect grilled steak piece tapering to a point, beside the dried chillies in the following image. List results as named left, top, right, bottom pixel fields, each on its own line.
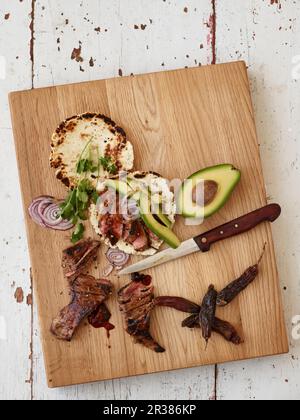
left=118, top=273, right=165, bottom=353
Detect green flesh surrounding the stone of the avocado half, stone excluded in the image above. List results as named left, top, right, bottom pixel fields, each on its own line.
left=178, top=164, right=241, bottom=219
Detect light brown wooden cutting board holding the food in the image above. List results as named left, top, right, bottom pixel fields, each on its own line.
left=10, top=62, right=288, bottom=387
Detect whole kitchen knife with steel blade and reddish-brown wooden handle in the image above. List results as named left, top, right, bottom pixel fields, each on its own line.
left=119, top=204, right=281, bottom=276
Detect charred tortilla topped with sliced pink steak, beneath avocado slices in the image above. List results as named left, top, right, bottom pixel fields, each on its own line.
left=90, top=172, right=176, bottom=256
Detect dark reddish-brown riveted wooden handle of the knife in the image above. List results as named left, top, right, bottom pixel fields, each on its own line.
left=194, top=204, right=281, bottom=252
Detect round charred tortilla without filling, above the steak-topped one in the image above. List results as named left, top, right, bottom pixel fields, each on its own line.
left=50, top=113, right=134, bottom=188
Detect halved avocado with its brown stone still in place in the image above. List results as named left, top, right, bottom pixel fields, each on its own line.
left=177, top=164, right=241, bottom=219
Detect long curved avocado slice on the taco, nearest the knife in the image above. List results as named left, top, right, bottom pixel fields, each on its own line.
left=140, top=193, right=181, bottom=248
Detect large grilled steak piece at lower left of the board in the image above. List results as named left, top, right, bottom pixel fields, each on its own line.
left=51, top=275, right=113, bottom=341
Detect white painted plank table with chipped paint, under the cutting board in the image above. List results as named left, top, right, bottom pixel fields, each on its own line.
left=0, top=0, right=300, bottom=400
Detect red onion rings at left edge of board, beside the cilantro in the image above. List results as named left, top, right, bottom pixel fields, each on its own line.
left=28, top=196, right=74, bottom=231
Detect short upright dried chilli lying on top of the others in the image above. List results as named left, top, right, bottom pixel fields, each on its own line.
left=199, top=285, right=218, bottom=343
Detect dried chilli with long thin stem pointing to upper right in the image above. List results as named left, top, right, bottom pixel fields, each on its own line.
left=217, top=244, right=266, bottom=306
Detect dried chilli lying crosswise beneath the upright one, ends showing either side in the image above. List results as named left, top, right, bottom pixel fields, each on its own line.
left=182, top=314, right=244, bottom=345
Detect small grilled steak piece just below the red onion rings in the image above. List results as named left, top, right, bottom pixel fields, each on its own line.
left=62, top=239, right=100, bottom=285
